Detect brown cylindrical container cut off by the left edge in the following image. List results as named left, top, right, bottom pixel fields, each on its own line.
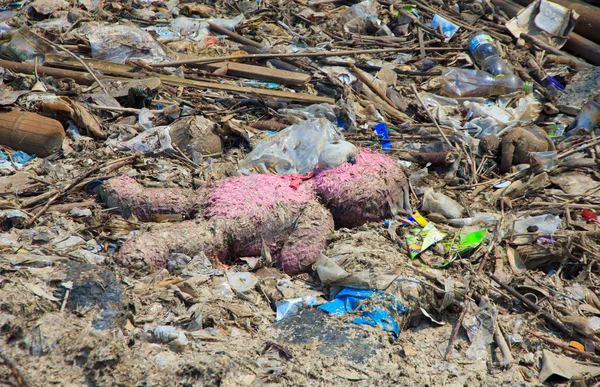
left=0, top=111, right=65, bottom=157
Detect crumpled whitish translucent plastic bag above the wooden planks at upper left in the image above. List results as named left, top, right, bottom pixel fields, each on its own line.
left=82, top=23, right=169, bottom=63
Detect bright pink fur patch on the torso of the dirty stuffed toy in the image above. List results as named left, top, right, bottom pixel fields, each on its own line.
left=205, top=174, right=315, bottom=219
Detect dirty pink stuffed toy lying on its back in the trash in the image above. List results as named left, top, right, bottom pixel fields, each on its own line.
left=101, top=146, right=409, bottom=274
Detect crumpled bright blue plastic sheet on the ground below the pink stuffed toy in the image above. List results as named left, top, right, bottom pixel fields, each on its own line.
left=319, top=288, right=408, bottom=338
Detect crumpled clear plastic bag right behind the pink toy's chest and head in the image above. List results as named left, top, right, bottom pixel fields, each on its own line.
left=240, top=118, right=344, bottom=175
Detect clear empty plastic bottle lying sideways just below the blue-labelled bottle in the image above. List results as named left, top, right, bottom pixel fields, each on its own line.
left=440, top=68, right=531, bottom=98
